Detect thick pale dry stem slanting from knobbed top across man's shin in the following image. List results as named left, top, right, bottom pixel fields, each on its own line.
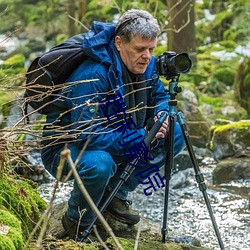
left=61, top=149, right=124, bottom=250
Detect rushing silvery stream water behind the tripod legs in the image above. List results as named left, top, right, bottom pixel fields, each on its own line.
left=39, top=157, right=250, bottom=250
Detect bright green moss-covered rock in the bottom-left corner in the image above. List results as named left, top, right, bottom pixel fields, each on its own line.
left=0, top=209, right=24, bottom=250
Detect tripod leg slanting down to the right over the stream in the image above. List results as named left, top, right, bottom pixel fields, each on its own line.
left=177, top=112, right=225, bottom=250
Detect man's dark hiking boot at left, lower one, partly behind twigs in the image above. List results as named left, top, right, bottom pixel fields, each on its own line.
left=62, top=213, right=97, bottom=243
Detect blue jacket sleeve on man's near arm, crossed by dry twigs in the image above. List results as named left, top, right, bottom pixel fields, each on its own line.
left=66, top=60, right=145, bottom=155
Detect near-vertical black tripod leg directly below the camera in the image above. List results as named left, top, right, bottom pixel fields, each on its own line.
left=161, top=114, right=175, bottom=243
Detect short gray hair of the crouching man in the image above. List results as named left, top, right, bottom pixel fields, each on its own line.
left=116, top=9, right=160, bottom=43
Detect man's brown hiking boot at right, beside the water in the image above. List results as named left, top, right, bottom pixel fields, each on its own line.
left=105, top=197, right=140, bottom=225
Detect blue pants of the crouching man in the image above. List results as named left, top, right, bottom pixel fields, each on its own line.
left=42, top=123, right=185, bottom=226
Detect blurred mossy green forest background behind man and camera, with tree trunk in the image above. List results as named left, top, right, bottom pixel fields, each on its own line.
left=0, top=0, right=250, bottom=127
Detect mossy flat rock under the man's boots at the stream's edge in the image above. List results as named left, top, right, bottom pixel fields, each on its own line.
left=43, top=202, right=209, bottom=250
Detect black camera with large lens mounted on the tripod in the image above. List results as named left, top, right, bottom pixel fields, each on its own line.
left=156, top=51, right=192, bottom=80
